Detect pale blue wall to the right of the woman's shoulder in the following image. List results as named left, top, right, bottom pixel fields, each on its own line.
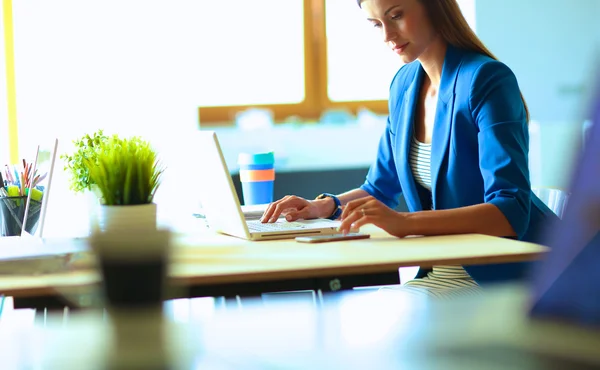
left=476, top=0, right=600, bottom=122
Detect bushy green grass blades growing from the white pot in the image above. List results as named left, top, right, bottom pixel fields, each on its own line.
left=86, top=136, right=164, bottom=205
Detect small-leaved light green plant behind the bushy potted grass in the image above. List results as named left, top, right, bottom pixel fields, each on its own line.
left=60, top=130, right=109, bottom=192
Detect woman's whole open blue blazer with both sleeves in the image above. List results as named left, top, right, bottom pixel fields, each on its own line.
left=361, top=46, right=557, bottom=283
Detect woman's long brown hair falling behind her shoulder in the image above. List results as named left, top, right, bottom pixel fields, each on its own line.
left=357, top=0, right=529, bottom=122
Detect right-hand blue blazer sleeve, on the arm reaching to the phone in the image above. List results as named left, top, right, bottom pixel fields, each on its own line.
left=469, top=61, right=531, bottom=239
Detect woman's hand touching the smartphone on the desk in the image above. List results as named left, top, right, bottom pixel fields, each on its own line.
left=339, top=196, right=410, bottom=238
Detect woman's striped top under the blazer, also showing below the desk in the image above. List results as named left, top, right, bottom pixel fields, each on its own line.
left=408, top=135, right=476, bottom=288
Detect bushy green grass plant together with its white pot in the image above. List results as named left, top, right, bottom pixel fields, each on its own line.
left=84, top=135, right=164, bottom=230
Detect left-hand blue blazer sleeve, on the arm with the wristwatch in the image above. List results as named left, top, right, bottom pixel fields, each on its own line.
left=360, top=117, right=402, bottom=209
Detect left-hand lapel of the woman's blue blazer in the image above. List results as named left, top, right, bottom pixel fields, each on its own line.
left=396, top=66, right=425, bottom=212
